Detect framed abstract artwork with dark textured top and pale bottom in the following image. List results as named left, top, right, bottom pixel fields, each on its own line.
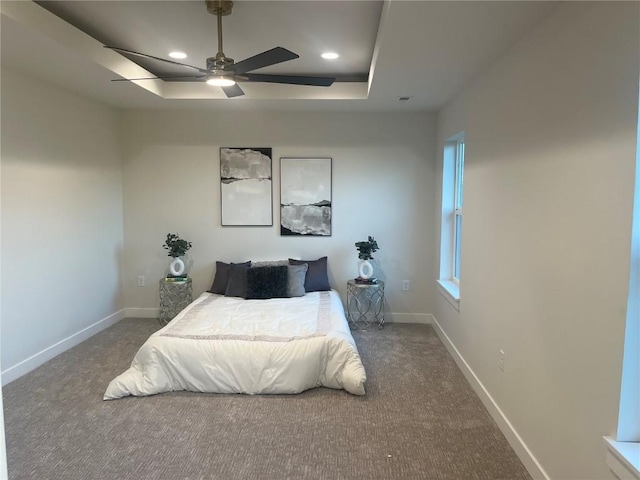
left=220, top=147, right=273, bottom=227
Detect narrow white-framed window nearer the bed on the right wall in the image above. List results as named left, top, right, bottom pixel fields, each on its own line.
left=438, top=133, right=465, bottom=308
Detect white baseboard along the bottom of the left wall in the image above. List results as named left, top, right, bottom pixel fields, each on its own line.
left=1, top=310, right=125, bottom=386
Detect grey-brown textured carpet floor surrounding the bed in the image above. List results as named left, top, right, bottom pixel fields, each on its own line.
left=3, top=319, right=530, bottom=480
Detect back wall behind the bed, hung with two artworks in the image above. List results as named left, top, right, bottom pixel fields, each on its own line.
left=122, top=111, right=437, bottom=321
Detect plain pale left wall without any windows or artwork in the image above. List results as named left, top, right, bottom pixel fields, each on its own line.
left=1, top=70, right=123, bottom=381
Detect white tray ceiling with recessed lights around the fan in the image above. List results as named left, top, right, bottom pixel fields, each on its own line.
left=0, top=0, right=557, bottom=111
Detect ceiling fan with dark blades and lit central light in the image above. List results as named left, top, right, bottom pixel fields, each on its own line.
left=105, top=0, right=336, bottom=98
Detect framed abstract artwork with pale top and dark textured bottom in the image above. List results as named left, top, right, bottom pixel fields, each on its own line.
left=280, top=157, right=331, bottom=237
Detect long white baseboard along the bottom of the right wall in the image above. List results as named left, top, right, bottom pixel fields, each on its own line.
left=432, top=317, right=550, bottom=480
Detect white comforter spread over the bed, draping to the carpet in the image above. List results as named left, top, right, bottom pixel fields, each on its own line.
left=104, top=291, right=366, bottom=400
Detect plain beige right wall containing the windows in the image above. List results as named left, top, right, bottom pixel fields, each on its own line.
left=435, top=2, right=639, bottom=479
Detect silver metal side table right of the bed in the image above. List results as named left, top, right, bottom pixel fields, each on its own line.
left=347, top=280, right=384, bottom=330
